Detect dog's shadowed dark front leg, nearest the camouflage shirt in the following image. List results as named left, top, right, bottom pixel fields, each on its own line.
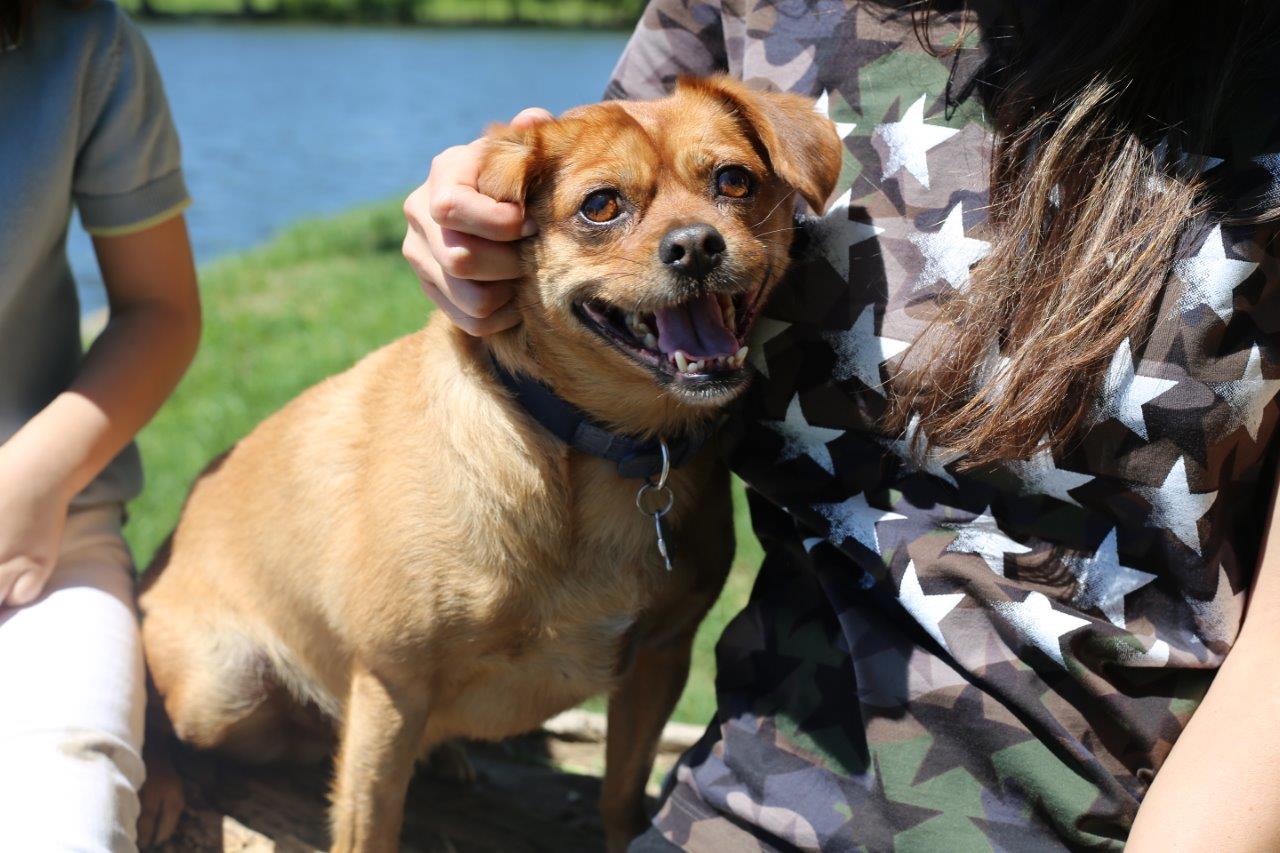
left=600, top=621, right=698, bottom=853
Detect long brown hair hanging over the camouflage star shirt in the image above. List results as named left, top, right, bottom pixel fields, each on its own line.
left=890, top=0, right=1277, bottom=467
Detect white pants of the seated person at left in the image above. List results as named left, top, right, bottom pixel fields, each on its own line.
left=0, top=506, right=146, bottom=853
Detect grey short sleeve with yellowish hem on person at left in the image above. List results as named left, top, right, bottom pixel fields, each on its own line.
left=72, top=12, right=189, bottom=237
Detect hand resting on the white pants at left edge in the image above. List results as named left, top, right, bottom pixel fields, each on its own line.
left=0, top=447, right=70, bottom=607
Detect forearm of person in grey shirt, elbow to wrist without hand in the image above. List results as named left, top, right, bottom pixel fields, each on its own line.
left=0, top=302, right=200, bottom=500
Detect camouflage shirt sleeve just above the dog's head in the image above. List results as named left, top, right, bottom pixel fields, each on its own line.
left=604, top=0, right=728, bottom=100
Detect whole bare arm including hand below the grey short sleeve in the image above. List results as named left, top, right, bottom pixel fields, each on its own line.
left=0, top=216, right=200, bottom=605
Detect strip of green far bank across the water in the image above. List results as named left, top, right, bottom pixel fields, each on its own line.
left=119, top=0, right=644, bottom=28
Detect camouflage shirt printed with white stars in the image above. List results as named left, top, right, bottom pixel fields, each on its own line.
left=608, top=0, right=1280, bottom=850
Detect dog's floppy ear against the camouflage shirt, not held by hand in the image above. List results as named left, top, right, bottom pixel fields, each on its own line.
left=676, top=76, right=844, bottom=214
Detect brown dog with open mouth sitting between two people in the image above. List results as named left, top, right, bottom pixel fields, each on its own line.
left=141, top=78, right=841, bottom=850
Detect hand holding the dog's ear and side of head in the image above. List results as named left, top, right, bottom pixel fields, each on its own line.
left=403, top=108, right=552, bottom=337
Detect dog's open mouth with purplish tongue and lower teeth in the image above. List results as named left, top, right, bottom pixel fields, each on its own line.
left=575, top=293, right=755, bottom=380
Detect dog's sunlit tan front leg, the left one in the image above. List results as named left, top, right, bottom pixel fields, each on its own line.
left=332, top=663, right=426, bottom=853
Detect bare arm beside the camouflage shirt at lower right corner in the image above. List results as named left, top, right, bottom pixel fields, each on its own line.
left=1126, top=461, right=1280, bottom=853
